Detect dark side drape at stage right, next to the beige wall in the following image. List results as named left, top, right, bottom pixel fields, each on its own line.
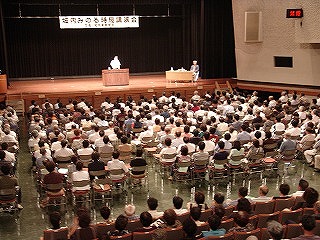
left=200, top=0, right=236, bottom=78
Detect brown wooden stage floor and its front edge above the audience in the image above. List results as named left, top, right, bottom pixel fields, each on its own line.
left=6, top=74, right=320, bottom=107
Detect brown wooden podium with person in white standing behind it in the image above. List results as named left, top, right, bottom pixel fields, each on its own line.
left=102, top=68, right=129, bottom=86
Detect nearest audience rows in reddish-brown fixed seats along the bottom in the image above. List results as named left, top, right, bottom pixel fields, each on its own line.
left=44, top=183, right=320, bottom=240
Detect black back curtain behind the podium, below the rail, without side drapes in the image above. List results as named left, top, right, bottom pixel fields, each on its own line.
left=7, top=18, right=183, bottom=78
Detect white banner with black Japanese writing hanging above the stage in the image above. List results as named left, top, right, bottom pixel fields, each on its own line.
left=59, top=16, right=139, bottom=29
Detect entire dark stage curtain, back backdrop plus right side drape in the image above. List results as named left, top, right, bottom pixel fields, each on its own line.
left=0, top=0, right=236, bottom=78
